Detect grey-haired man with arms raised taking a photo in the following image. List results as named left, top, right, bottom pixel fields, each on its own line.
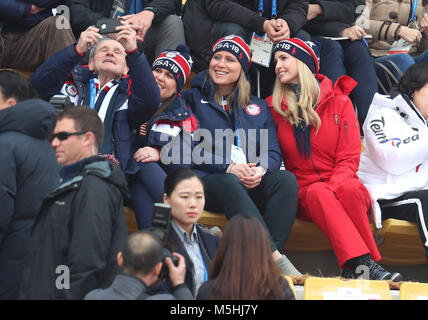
left=31, top=22, right=160, bottom=174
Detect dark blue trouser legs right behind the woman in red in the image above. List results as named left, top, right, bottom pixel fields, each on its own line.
left=312, top=36, right=378, bottom=123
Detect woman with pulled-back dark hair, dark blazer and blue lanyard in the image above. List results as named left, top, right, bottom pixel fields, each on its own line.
left=163, top=168, right=219, bottom=296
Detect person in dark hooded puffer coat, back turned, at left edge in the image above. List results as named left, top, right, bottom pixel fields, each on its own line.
left=0, top=70, right=59, bottom=299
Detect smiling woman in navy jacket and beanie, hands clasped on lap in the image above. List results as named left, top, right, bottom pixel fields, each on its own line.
left=182, top=35, right=300, bottom=275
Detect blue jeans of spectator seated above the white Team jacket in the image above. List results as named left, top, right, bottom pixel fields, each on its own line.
left=375, top=50, right=428, bottom=94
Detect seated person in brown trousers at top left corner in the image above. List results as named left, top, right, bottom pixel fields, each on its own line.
left=0, top=0, right=75, bottom=71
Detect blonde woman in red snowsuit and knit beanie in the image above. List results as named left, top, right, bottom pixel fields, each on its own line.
left=267, top=38, right=402, bottom=281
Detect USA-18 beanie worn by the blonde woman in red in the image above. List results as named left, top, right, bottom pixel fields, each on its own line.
left=273, top=38, right=320, bottom=75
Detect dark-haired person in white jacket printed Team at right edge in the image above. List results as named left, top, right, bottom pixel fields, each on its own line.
left=358, top=62, right=428, bottom=259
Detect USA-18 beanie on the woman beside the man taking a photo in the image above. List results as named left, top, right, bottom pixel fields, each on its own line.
left=152, top=44, right=193, bottom=92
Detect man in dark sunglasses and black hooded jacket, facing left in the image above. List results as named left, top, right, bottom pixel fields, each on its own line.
left=20, top=106, right=127, bottom=299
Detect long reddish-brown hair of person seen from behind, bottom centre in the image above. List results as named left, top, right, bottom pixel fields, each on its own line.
left=197, top=215, right=295, bottom=300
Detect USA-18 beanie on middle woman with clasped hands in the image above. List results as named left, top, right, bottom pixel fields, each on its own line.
left=211, top=34, right=251, bottom=74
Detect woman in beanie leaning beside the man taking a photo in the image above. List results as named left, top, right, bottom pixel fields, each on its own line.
left=130, top=44, right=198, bottom=229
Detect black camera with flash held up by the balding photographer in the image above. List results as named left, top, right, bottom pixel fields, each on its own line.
left=149, top=203, right=178, bottom=279
